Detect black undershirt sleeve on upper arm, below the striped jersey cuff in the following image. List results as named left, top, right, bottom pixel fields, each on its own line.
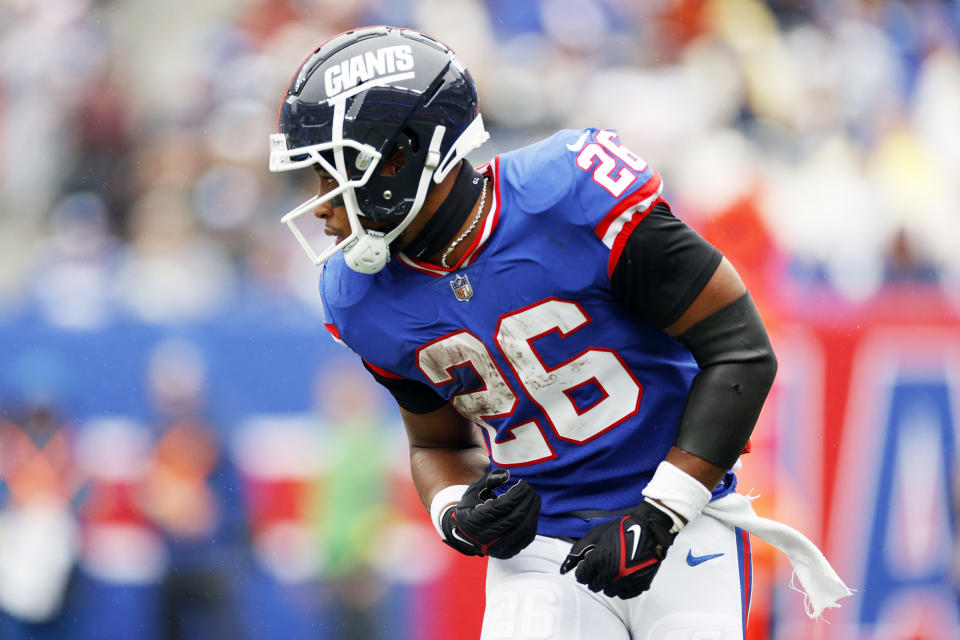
left=611, top=202, right=723, bottom=329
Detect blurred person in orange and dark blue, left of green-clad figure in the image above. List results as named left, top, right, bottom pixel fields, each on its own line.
left=140, top=339, right=248, bottom=640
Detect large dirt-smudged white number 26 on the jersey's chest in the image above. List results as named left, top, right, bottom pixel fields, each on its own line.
left=417, top=298, right=642, bottom=466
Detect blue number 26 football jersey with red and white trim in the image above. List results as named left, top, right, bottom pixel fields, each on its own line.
left=320, top=129, right=734, bottom=536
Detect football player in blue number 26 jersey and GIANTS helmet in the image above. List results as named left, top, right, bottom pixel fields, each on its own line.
left=270, top=27, right=849, bottom=640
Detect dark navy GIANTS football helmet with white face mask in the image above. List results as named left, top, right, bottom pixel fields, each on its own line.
left=270, top=27, right=489, bottom=273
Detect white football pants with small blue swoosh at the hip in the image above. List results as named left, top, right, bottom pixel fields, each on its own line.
left=481, top=504, right=753, bottom=640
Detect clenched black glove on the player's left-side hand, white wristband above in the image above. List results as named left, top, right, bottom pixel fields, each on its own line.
left=440, top=469, right=540, bottom=558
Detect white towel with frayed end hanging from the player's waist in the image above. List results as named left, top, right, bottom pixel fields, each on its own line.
left=703, top=493, right=853, bottom=618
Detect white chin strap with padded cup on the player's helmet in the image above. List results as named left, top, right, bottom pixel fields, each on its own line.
left=343, top=126, right=445, bottom=274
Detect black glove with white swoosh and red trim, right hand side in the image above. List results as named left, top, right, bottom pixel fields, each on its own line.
left=560, top=502, right=679, bottom=598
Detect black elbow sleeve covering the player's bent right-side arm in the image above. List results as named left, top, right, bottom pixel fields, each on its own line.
left=674, top=293, right=777, bottom=469
